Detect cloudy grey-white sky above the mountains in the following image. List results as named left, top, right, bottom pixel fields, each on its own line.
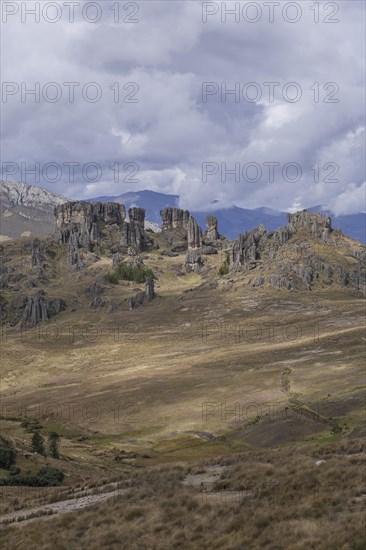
left=1, top=0, right=365, bottom=214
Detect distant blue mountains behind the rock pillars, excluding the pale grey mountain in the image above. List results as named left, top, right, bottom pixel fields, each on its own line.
left=88, top=191, right=366, bottom=243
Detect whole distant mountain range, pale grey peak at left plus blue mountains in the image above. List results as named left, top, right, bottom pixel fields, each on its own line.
left=0, top=182, right=366, bottom=243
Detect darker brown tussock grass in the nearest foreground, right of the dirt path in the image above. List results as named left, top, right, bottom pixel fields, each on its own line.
left=1, top=440, right=366, bottom=550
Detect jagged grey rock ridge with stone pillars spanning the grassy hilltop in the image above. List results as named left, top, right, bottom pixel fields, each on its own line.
left=0, top=206, right=366, bottom=326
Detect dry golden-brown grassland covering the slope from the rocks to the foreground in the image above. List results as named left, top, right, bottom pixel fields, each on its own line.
left=0, top=235, right=366, bottom=550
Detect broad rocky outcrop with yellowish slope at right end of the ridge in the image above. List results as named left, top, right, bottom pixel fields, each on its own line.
left=229, top=210, right=366, bottom=293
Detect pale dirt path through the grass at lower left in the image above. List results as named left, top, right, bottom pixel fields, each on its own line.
left=0, top=487, right=128, bottom=528
